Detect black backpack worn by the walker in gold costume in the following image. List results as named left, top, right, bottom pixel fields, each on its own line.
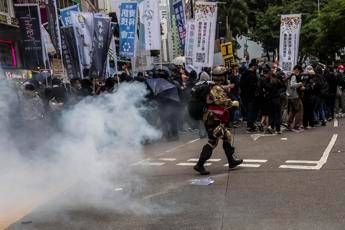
left=188, top=81, right=210, bottom=120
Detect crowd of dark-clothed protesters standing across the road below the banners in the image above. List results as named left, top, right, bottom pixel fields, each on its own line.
left=7, top=60, right=345, bottom=140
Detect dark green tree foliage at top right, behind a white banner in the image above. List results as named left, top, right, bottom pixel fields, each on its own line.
left=247, top=0, right=345, bottom=60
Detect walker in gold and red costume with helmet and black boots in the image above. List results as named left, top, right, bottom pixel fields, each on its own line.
left=194, top=66, right=243, bottom=175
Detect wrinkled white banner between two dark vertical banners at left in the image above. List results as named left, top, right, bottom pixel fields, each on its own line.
left=71, top=12, right=94, bottom=76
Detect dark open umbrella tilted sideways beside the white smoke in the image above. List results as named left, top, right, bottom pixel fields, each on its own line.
left=146, top=78, right=180, bottom=102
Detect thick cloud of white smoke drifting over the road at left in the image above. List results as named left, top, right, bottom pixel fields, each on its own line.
left=0, top=75, right=161, bottom=226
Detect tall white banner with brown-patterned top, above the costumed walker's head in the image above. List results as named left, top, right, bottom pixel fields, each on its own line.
left=193, top=2, right=217, bottom=69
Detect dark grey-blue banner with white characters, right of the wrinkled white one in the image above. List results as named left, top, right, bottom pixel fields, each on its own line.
left=90, top=15, right=113, bottom=78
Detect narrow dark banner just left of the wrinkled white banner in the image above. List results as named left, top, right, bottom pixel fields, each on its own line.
left=61, top=26, right=82, bottom=79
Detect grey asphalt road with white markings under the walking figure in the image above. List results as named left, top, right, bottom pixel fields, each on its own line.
left=4, top=120, right=345, bottom=230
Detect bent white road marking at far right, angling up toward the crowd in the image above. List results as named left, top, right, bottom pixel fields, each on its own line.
left=279, top=134, right=338, bottom=170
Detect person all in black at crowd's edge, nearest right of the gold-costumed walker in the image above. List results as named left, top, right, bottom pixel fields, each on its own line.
left=240, top=59, right=258, bottom=132
